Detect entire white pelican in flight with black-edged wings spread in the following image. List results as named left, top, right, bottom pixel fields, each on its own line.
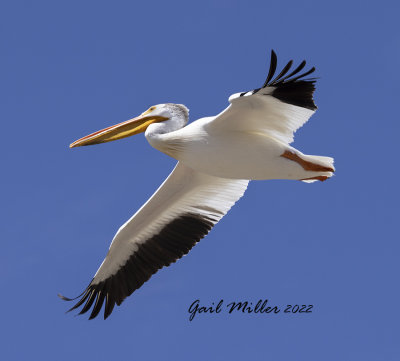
left=60, top=51, right=335, bottom=319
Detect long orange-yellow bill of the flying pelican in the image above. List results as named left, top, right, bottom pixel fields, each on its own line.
left=69, top=112, right=168, bottom=148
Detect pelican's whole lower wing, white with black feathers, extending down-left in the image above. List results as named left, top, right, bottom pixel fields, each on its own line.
left=60, top=163, right=249, bottom=319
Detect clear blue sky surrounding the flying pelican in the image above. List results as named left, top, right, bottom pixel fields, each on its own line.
left=0, top=0, right=400, bottom=361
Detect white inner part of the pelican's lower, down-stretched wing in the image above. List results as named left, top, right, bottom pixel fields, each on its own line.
left=94, top=163, right=249, bottom=282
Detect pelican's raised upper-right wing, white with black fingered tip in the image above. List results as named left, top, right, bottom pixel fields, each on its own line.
left=209, top=50, right=317, bottom=144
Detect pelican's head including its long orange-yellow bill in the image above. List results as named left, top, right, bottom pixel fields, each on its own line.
left=69, top=103, right=188, bottom=148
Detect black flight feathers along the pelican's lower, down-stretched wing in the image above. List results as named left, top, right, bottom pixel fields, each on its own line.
left=58, top=213, right=214, bottom=320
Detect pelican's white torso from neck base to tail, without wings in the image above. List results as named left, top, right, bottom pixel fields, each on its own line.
left=150, top=117, right=332, bottom=180
